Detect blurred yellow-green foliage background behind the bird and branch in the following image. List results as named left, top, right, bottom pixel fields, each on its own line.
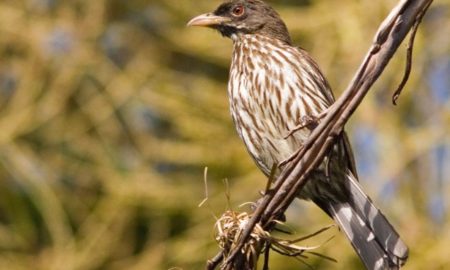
left=0, top=0, right=450, bottom=270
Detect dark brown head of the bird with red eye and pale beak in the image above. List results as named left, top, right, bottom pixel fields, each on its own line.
left=188, top=0, right=291, bottom=44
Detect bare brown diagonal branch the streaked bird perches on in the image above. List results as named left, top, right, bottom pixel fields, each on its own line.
left=206, top=0, right=433, bottom=269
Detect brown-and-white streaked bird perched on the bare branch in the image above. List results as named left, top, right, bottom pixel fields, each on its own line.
left=187, top=0, right=408, bottom=269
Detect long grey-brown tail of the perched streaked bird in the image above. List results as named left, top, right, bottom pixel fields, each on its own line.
left=320, top=175, right=408, bottom=270
